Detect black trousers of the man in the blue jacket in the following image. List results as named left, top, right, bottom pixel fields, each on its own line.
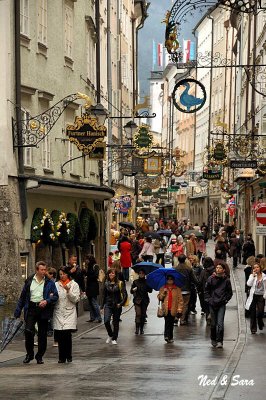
left=25, top=302, right=48, bottom=358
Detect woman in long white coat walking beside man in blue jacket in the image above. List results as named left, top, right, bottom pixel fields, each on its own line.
left=54, top=267, right=80, bottom=363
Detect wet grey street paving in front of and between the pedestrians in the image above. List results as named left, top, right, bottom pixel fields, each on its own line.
left=0, top=241, right=265, bottom=400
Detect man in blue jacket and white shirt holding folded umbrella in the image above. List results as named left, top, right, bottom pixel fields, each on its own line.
left=14, top=261, right=58, bottom=364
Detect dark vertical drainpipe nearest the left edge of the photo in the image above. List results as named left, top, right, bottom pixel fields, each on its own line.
left=14, top=0, right=28, bottom=222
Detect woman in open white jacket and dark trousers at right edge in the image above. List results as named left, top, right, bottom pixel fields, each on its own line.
left=245, top=264, right=266, bottom=334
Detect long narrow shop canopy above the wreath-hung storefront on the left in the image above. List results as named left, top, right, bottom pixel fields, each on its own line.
left=20, top=175, right=115, bottom=200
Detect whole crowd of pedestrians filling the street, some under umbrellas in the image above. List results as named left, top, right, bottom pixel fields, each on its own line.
left=14, top=220, right=266, bottom=364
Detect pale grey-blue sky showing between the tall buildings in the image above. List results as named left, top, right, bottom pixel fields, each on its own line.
left=139, top=0, right=200, bottom=96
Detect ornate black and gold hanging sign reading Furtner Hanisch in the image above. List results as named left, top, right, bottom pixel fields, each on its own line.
left=66, top=113, right=107, bottom=160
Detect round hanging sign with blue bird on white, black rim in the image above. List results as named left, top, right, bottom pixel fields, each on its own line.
left=172, top=79, right=207, bottom=113
